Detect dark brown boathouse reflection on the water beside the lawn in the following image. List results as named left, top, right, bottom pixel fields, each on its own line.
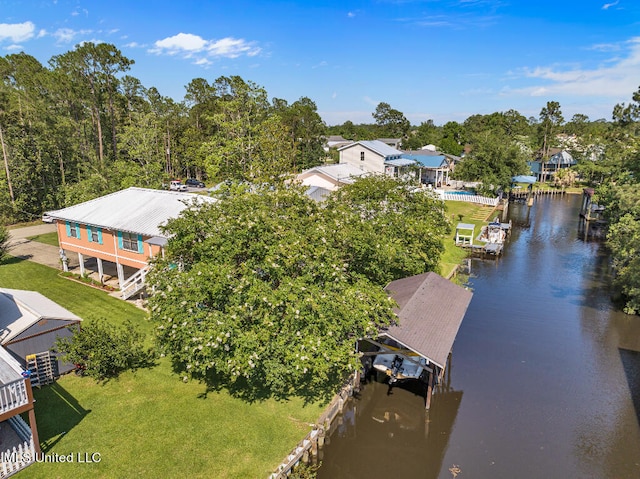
left=318, top=381, right=462, bottom=479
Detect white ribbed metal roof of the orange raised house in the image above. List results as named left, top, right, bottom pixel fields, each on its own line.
left=46, top=187, right=216, bottom=236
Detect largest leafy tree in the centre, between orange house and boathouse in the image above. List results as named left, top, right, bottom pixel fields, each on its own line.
left=149, top=185, right=393, bottom=398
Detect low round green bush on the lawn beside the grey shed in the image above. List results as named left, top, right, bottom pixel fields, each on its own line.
left=56, top=321, right=155, bottom=380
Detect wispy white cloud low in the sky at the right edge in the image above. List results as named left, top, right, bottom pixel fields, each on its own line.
left=510, top=37, right=640, bottom=98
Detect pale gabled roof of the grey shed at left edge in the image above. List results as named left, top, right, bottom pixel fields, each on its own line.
left=0, top=288, right=82, bottom=344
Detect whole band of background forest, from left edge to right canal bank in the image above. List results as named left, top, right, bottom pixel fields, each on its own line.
left=0, top=43, right=640, bottom=312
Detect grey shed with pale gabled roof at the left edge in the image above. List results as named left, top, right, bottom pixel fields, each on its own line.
left=0, top=288, right=82, bottom=374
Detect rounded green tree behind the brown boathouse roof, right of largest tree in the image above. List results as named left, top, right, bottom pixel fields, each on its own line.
left=327, top=176, right=450, bottom=285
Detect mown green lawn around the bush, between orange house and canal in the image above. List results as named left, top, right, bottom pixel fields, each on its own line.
left=0, top=258, right=322, bottom=479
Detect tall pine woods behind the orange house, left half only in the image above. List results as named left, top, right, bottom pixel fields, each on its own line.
left=0, top=43, right=325, bottom=223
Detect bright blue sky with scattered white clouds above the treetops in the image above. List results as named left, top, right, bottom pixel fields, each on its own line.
left=0, top=0, right=640, bottom=125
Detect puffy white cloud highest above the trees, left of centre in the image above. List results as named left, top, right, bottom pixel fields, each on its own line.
left=149, top=33, right=261, bottom=65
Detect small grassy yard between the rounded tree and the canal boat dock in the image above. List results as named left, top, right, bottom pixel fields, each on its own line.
left=440, top=201, right=494, bottom=278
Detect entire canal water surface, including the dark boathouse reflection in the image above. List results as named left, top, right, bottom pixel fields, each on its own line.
left=318, top=195, right=640, bottom=479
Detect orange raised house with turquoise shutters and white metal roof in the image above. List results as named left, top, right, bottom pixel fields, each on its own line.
left=46, top=187, right=215, bottom=299
